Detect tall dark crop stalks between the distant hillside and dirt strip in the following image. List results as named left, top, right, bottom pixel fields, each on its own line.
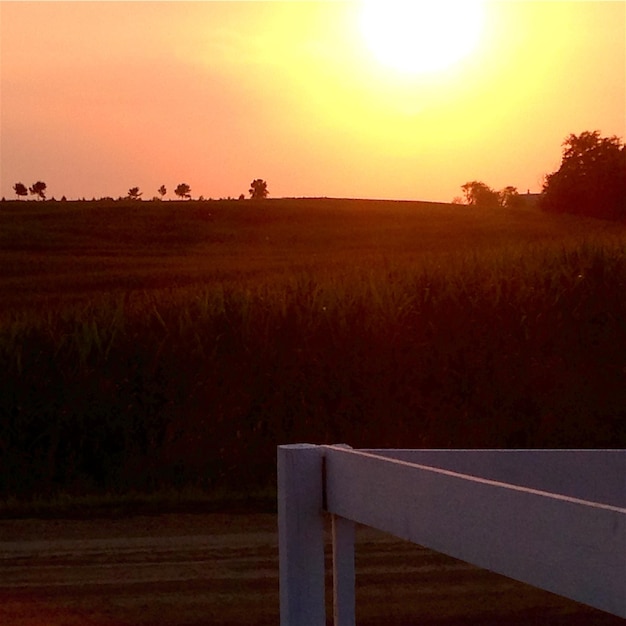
left=0, top=200, right=626, bottom=497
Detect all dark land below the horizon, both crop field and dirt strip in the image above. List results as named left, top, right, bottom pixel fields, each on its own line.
left=0, top=200, right=626, bottom=626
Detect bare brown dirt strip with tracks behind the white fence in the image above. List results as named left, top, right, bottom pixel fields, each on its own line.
left=0, top=514, right=624, bottom=626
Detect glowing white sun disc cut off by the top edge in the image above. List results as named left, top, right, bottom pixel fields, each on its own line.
left=360, top=0, right=483, bottom=74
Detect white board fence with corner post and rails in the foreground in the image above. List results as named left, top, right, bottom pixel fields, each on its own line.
left=278, top=444, right=626, bottom=626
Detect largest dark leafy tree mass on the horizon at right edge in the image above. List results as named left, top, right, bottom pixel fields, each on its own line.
left=541, top=130, right=626, bottom=218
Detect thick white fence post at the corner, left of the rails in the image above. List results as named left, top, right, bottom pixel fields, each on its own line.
left=277, top=444, right=326, bottom=626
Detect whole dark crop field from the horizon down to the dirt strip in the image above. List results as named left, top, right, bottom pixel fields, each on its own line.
left=0, top=199, right=626, bottom=501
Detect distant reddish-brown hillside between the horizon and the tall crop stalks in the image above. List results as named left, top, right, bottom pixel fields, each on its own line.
left=0, top=199, right=626, bottom=307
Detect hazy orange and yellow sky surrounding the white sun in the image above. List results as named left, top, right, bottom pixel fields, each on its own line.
left=0, top=1, right=626, bottom=201
